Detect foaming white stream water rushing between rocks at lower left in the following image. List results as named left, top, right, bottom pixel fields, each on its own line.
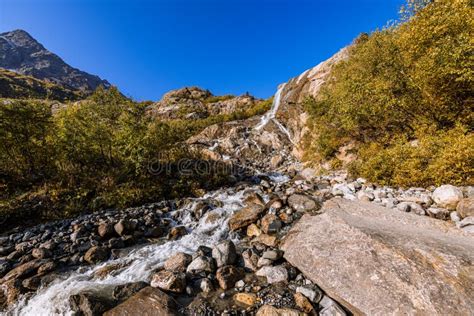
left=7, top=186, right=262, bottom=316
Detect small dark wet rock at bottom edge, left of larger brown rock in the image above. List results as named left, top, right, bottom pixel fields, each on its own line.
left=69, top=292, right=113, bottom=316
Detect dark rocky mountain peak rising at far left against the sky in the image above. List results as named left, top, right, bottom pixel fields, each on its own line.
left=0, top=30, right=110, bottom=91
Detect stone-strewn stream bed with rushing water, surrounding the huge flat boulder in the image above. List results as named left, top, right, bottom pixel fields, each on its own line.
left=0, top=169, right=474, bottom=315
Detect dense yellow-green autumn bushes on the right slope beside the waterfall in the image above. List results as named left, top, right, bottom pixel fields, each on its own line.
left=305, top=0, right=474, bottom=186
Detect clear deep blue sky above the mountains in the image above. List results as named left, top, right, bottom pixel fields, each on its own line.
left=0, top=0, right=404, bottom=100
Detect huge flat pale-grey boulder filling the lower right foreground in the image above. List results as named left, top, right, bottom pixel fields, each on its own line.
left=282, top=198, right=474, bottom=315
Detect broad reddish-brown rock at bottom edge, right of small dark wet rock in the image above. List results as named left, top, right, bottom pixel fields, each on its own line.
left=104, top=286, right=179, bottom=316
